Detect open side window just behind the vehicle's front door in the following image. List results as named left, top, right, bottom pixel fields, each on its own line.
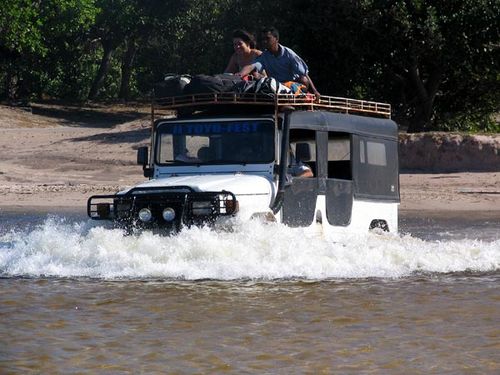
left=328, top=132, right=352, bottom=180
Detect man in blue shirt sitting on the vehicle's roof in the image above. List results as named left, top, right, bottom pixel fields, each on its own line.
left=238, top=27, right=320, bottom=97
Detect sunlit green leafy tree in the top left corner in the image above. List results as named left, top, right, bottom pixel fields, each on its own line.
left=0, top=0, right=95, bottom=99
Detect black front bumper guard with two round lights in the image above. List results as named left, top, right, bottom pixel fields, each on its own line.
left=87, top=186, right=238, bottom=230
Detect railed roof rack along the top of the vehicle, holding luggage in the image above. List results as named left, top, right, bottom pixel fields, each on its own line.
left=151, top=93, right=391, bottom=120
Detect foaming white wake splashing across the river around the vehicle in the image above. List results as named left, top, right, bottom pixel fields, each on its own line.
left=0, top=218, right=500, bottom=280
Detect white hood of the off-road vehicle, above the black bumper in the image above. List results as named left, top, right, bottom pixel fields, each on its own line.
left=123, top=174, right=273, bottom=195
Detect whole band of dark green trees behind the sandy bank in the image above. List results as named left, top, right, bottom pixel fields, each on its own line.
left=0, top=0, right=500, bottom=132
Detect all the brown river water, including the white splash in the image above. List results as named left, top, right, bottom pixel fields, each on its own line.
left=0, top=213, right=500, bottom=374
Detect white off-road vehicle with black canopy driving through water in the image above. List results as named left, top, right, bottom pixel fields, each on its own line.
left=87, top=93, right=399, bottom=234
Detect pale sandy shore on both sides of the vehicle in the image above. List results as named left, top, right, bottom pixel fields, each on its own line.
left=0, top=105, right=500, bottom=217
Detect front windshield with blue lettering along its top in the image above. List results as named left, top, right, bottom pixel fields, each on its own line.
left=156, top=120, right=274, bottom=165
